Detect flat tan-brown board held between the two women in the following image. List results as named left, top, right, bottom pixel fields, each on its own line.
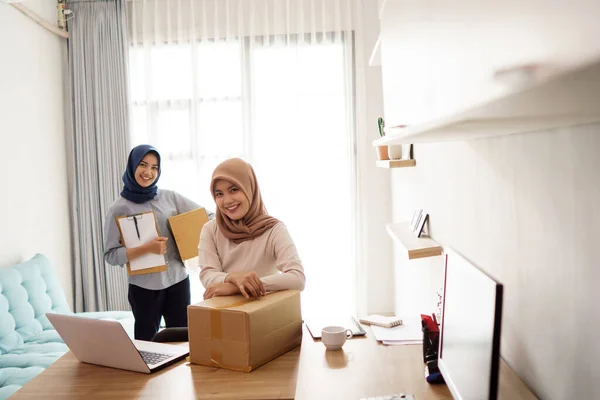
left=169, top=208, right=208, bottom=261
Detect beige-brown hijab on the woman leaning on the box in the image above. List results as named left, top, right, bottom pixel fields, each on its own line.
left=210, top=158, right=279, bottom=243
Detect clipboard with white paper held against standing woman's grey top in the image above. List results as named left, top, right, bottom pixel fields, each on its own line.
left=115, top=211, right=167, bottom=275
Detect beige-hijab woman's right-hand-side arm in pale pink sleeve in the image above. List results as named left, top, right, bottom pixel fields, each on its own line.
left=261, top=224, right=306, bottom=292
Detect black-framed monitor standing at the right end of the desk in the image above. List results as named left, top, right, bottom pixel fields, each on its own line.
left=438, top=249, right=503, bottom=400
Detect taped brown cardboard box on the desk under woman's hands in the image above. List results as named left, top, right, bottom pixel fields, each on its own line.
left=188, top=290, right=302, bottom=372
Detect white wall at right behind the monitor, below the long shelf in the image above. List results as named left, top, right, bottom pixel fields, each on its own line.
left=392, top=125, right=600, bottom=399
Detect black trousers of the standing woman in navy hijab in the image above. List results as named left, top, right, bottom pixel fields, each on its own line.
left=128, top=277, right=191, bottom=340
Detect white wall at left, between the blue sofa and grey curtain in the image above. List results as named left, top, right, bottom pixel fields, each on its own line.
left=0, top=0, right=72, bottom=305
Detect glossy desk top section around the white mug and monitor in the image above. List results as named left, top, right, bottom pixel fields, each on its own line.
left=296, top=327, right=537, bottom=400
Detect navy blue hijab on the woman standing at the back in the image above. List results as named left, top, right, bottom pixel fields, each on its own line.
left=121, top=144, right=160, bottom=204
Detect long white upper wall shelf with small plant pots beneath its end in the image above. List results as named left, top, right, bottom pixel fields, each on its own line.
left=373, top=60, right=600, bottom=146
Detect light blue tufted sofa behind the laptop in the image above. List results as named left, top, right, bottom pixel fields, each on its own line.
left=0, top=254, right=133, bottom=399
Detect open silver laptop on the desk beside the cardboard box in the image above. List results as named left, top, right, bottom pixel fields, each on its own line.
left=46, top=313, right=190, bottom=374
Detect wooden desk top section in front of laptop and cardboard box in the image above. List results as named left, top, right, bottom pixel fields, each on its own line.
left=11, top=347, right=300, bottom=400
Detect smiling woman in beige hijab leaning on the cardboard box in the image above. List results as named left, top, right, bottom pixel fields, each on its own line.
left=198, top=158, right=305, bottom=299
